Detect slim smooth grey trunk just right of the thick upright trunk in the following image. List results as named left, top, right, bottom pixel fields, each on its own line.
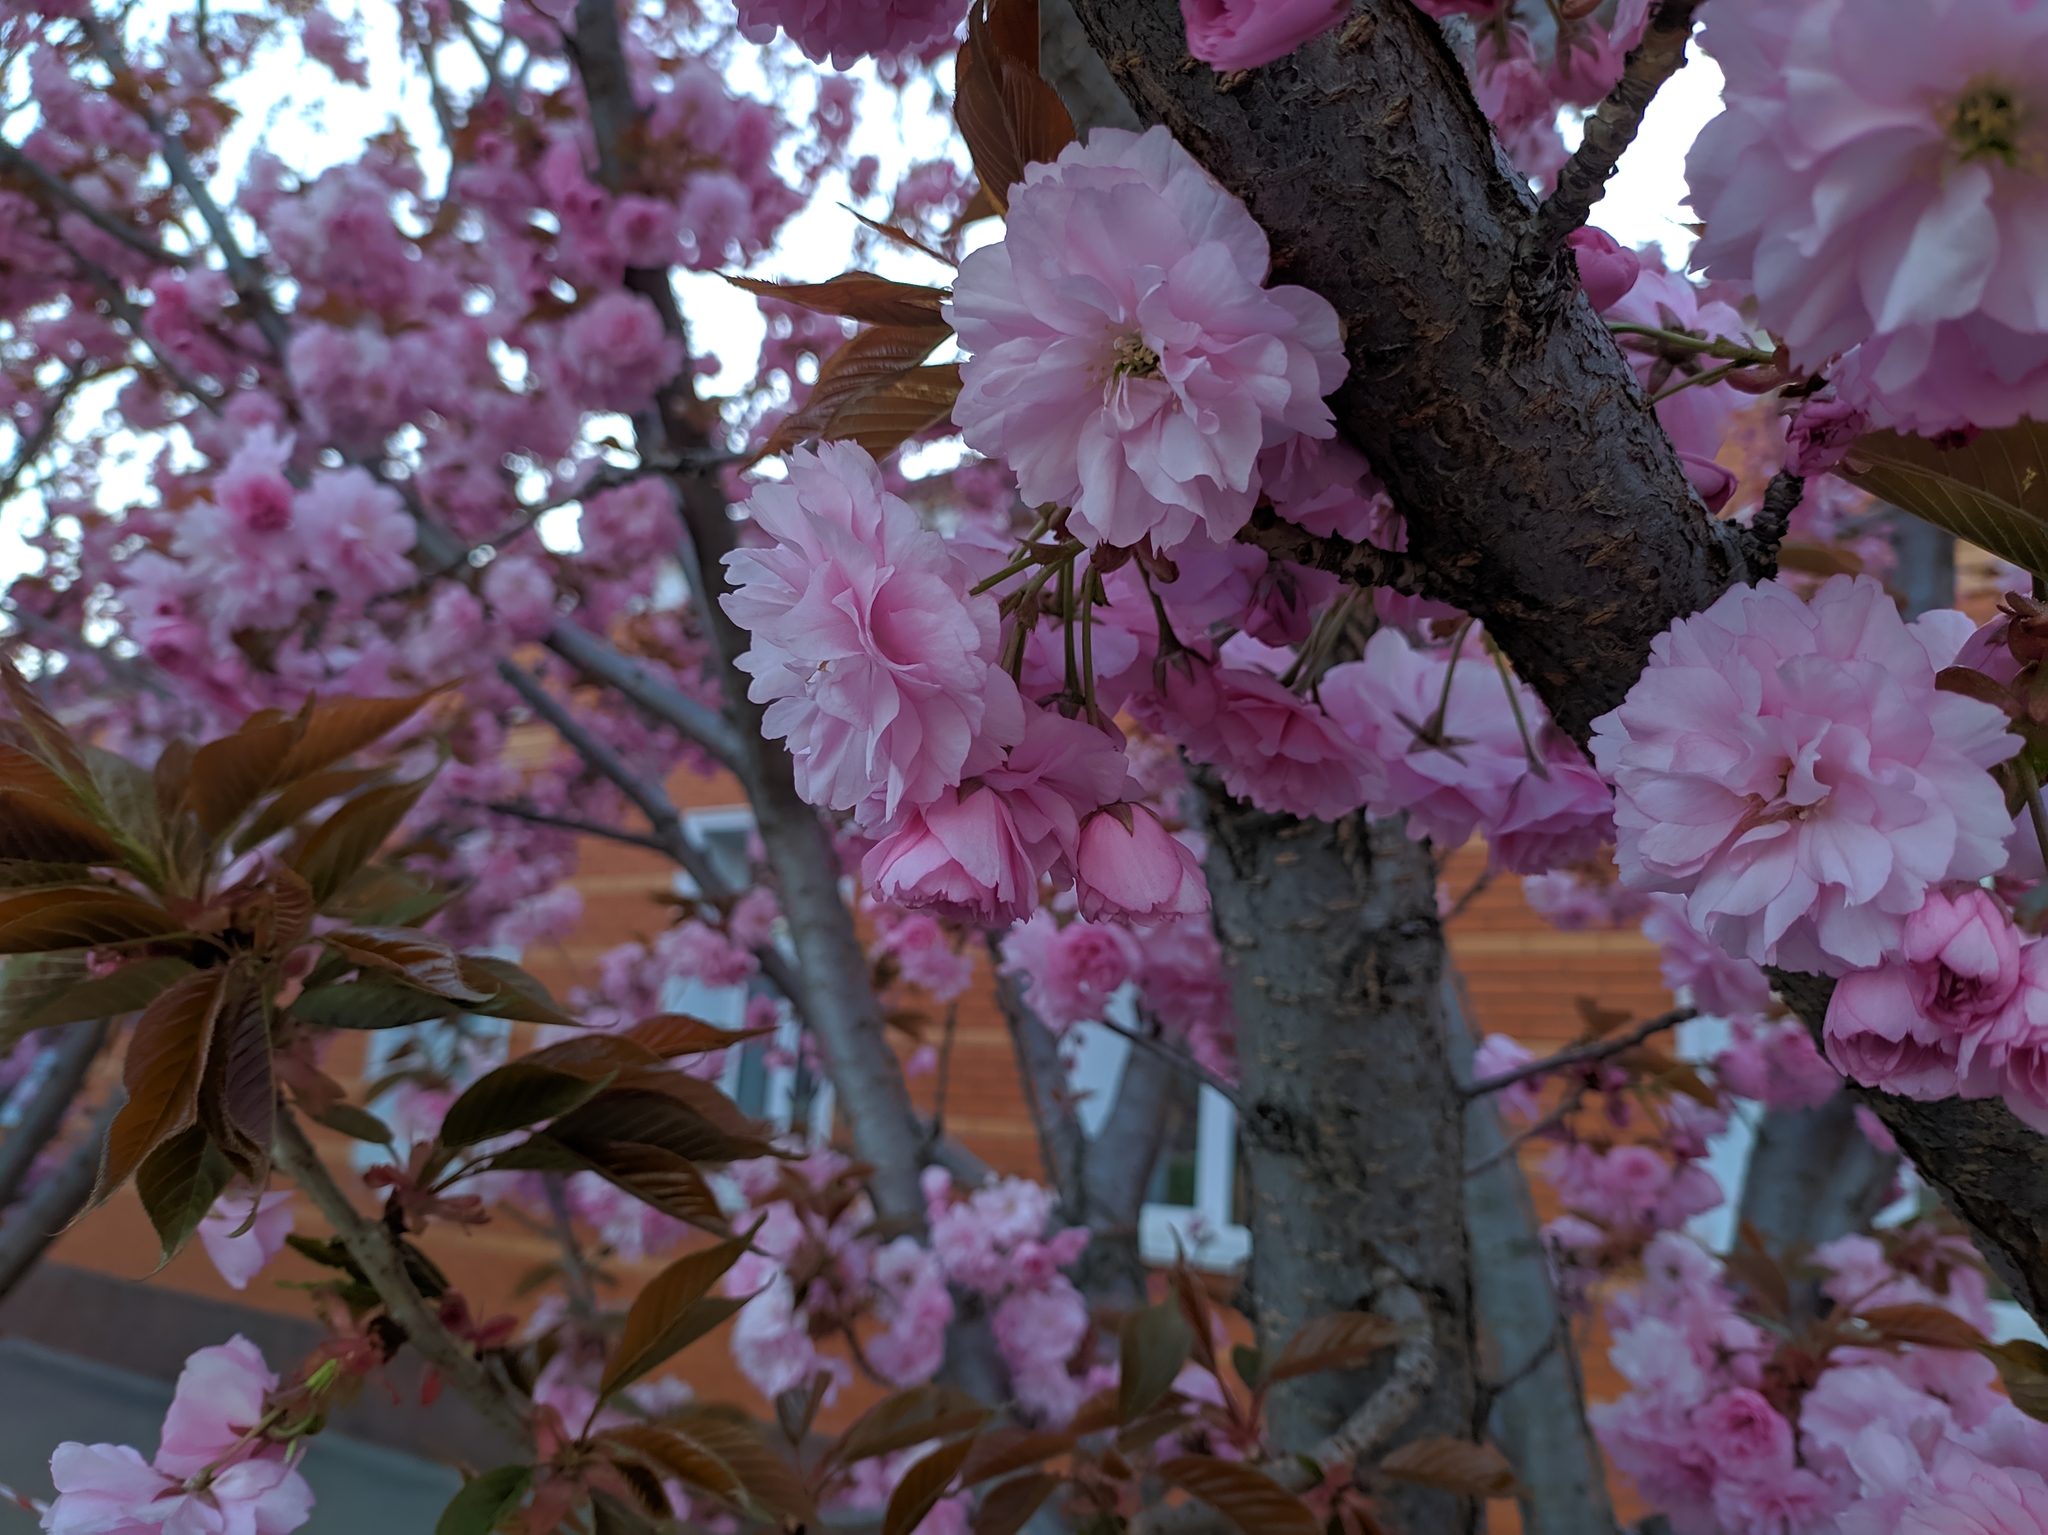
left=1444, top=976, right=1616, bottom=1535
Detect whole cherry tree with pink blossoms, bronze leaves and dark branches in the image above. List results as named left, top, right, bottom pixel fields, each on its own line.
left=0, top=0, right=2048, bottom=1535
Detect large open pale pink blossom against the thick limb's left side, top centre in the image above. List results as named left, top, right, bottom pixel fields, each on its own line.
left=948, top=127, right=1348, bottom=549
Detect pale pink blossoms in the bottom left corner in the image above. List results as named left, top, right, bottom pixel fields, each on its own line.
left=43, top=1336, right=313, bottom=1535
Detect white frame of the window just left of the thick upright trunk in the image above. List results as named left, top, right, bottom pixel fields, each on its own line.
left=1061, top=986, right=1251, bottom=1271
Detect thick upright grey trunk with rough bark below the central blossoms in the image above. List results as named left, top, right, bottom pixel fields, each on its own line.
left=1208, top=786, right=1479, bottom=1535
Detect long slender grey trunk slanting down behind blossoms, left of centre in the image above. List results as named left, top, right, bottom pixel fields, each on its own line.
left=571, top=0, right=926, bottom=1228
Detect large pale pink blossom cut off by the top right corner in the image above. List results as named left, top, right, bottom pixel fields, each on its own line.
left=1686, top=0, right=2048, bottom=432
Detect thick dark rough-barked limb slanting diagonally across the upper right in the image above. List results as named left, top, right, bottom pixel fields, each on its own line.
left=1075, top=0, right=2048, bottom=1318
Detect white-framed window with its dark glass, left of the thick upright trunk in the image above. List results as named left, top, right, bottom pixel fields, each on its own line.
left=1065, top=986, right=1251, bottom=1269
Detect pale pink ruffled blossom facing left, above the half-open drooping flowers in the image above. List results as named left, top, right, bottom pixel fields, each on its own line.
left=723, top=442, right=1024, bottom=825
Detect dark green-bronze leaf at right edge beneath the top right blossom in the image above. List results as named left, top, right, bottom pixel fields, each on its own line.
left=1835, top=422, right=2048, bottom=575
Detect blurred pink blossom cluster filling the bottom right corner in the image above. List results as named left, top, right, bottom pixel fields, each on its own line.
left=1589, top=1234, right=2048, bottom=1535
